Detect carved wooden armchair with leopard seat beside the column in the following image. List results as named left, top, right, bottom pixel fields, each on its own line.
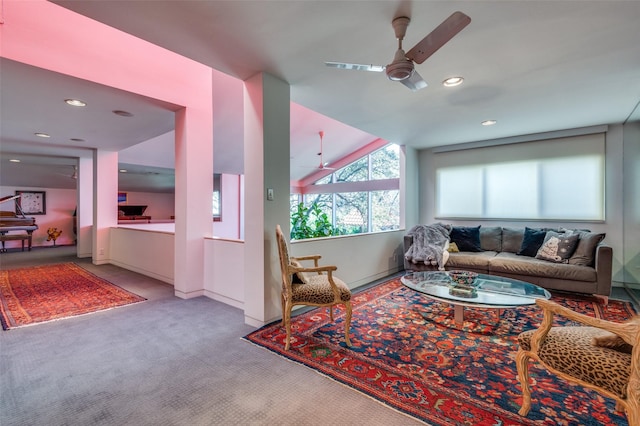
left=276, top=225, right=351, bottom=351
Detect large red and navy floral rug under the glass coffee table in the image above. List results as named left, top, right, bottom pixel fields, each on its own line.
left=245, top=279, right=635, bottom=425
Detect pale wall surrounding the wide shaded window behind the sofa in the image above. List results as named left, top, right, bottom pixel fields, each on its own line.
left=419, top=125, right=639, bottom=283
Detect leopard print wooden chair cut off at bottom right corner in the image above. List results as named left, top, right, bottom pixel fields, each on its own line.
left=516, top=299, right=640, bottom=425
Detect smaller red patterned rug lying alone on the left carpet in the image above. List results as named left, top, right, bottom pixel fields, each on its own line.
left=0, top=263, right=146, bottom=330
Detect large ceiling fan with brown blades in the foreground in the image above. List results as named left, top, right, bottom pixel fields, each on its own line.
left=325, top=12, right=471, bottom=92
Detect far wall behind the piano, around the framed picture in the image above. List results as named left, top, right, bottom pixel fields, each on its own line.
left=0, top=186, right=76, bottom=250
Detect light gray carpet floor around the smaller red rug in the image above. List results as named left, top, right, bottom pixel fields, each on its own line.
left=0, top=248, right=419, bottom=426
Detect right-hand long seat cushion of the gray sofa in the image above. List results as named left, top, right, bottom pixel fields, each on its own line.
left=489, top=252, right=597, bottom=282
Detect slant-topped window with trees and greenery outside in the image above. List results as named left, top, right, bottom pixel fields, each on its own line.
left=291, top=144, right=400, bottom=235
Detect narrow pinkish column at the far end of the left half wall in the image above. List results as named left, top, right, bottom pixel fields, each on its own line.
left=93, top=150, right=118, bottom=265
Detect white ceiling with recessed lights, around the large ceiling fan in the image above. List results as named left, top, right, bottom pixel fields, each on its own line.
left=0, top=0, right=640, bottom=193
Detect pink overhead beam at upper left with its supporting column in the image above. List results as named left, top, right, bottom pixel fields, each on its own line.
left=0, top=0, right=213, bottom=297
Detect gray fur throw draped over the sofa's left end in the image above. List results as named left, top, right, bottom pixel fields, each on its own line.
left=404, top=223, right=451, bottom=270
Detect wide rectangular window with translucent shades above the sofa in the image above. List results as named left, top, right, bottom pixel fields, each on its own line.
left=435, top=134, right=605, bottom=221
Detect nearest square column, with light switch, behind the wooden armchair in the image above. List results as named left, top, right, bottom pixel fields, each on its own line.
left=244, top=74, right=291, bottom=325
